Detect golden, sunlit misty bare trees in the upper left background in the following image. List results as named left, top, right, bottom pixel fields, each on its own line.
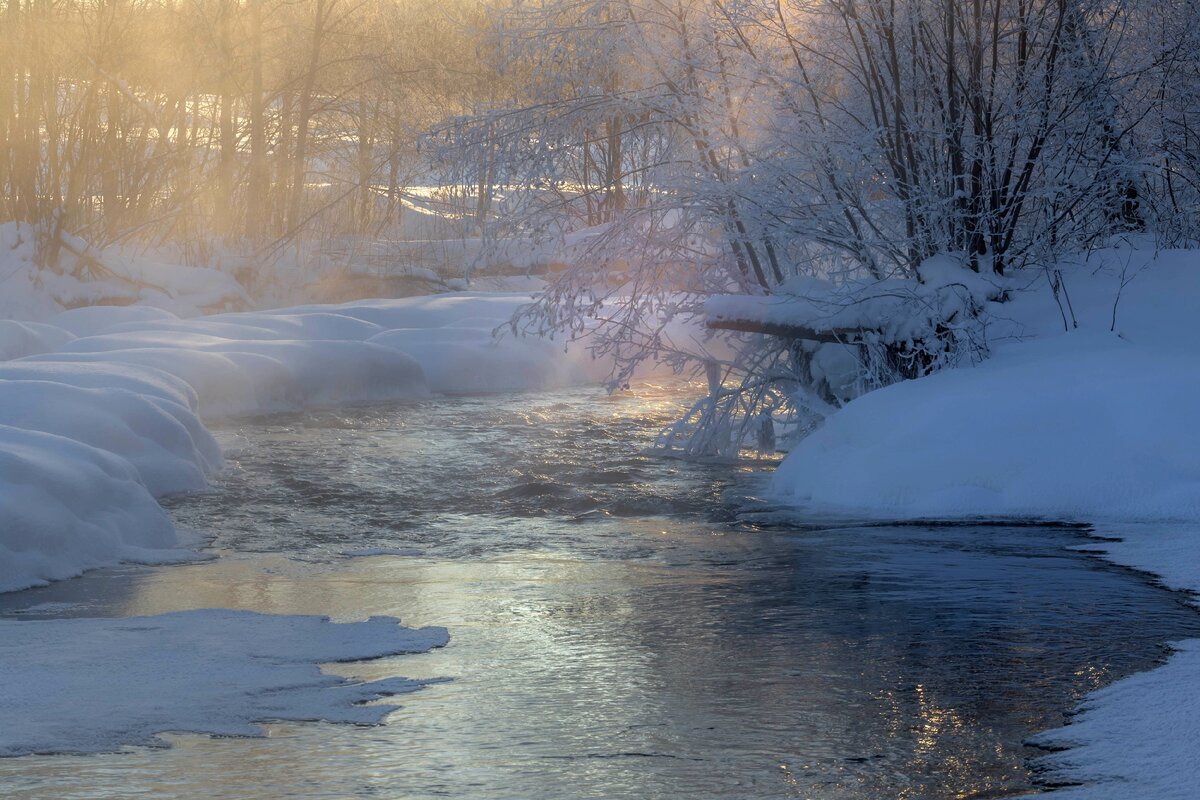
left=0, top=0, right=493, bottom=266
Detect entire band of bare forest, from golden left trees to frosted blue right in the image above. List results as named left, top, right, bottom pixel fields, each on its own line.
left=0, top=0, right=1200, bottom=438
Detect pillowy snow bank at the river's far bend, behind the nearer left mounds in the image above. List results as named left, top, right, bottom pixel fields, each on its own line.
left=36, top=291, right=605, bottom=419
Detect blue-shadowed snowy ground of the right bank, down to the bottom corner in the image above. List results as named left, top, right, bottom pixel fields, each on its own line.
left=773, top=248, right=1200, bottom=799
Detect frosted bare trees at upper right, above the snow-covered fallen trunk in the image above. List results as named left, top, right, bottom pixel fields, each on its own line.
left=440, top=0, right=1200, bottom=371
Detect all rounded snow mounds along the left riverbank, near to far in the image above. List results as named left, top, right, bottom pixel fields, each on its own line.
left=0, top=287, right=604, bottom=591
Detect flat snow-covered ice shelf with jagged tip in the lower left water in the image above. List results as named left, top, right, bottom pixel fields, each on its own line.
left=0, top=609, right=448, bottom=756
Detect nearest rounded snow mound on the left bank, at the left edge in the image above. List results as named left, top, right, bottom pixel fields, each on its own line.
left=0, top=424, right=185, bottom=594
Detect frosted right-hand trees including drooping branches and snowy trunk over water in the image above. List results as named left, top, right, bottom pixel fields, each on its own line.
left=431, top=0, right=1198, bottom=455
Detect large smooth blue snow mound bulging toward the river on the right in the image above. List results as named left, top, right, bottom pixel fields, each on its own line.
left=773, top=331, right=1200, bottom=521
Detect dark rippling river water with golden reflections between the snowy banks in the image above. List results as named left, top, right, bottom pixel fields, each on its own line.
left=0, top=389, right=1200, bottom=800
